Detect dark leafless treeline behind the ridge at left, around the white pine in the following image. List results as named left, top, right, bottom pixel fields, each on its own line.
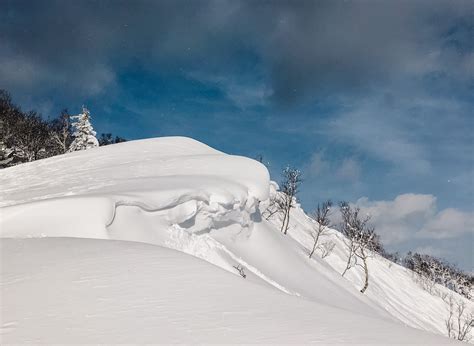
left=0, top=90, right=125, bottom=168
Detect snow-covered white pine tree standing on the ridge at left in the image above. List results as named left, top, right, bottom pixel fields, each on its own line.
left=69, top=106, right=99, bottom=151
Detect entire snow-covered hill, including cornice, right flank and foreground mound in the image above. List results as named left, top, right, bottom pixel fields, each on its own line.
left=0, top=137, right=472, bottom=344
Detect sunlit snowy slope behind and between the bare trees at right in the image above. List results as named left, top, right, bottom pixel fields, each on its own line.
left=272, top=195, right=474, bottom=335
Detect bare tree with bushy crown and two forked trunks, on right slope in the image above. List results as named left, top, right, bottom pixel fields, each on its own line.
left=339, top=202, right=380, bottom=293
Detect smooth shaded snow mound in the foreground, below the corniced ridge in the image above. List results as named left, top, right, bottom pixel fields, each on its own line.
left=0, top=238, right=448, bottom=344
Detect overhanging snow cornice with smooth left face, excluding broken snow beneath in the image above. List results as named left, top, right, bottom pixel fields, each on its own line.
left=0, top=137, right=269, bottom=238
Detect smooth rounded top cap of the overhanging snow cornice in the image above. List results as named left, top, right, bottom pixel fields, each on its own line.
left=0, top=137, right=269, bottom=208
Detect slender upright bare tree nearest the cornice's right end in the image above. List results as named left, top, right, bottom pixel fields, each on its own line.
left=276, top=166, right=301, bottom=234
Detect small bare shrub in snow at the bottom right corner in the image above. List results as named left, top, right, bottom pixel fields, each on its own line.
left=445, top=295, right=474, bottom=342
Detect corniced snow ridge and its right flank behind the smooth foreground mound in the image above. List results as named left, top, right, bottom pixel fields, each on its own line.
left=0, top=137, right=466, bottom=343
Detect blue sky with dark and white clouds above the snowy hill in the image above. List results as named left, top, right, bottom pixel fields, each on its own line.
left=0, top=0, right=474, bottom=270
